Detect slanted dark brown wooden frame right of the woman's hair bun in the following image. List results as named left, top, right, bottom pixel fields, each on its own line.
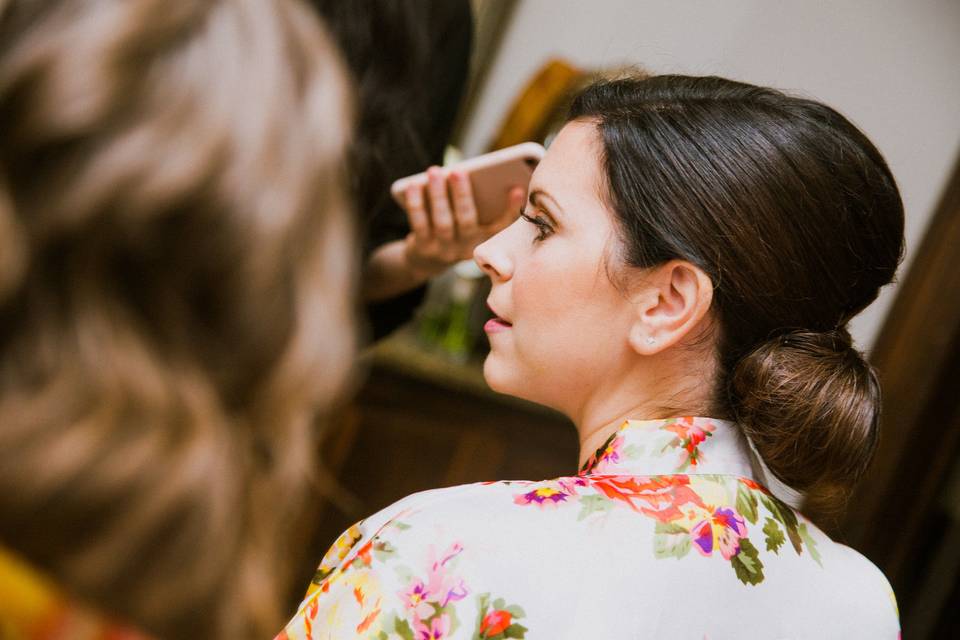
left=838, top=150, right=960, bottom=619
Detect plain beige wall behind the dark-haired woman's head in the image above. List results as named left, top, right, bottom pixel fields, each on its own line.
left=463, top=0, right=960, bottom=349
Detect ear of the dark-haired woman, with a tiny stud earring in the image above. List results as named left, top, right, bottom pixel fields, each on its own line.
left=629, top=260, right=713, bottom=355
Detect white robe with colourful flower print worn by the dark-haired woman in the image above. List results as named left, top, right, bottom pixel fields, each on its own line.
left=277, top=418, right=899, bottom=640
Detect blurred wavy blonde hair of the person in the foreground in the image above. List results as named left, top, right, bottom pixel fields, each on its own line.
left=0, top=0, right=355, bottom=638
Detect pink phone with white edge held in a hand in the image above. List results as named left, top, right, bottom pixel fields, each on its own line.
left=390, top=142, right=545, bottom=224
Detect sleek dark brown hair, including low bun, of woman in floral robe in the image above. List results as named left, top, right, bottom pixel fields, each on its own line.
left=569, top=76, right=903, bottom=508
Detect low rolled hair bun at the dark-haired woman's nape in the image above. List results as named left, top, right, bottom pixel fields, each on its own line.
left=730, top=328, right=880, bottom=504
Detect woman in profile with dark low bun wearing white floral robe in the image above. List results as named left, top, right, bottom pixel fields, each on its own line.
left=285, top=76, right=903, bottom=640
